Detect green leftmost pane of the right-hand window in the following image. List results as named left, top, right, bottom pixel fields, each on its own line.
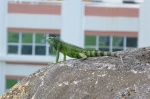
left=85, top=36, right=96, bottom=46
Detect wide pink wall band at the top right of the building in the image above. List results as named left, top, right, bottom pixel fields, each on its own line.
left=85, top=6, right=139, bottom=17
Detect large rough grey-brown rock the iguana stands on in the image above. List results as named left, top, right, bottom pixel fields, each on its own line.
left=0, top=47, right=150, bottom=99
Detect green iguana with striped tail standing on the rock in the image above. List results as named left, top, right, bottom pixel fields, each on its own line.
left=47, top=37, right=117, bottom=63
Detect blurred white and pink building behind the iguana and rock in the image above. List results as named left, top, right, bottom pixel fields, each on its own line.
left=0, top=0, right=150, bottom=95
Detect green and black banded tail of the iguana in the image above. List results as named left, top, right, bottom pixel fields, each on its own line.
left=85, top=50, right=117, bottom=57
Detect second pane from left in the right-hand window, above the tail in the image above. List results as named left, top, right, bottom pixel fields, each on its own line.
left=99, top=36, right=110, bottom=47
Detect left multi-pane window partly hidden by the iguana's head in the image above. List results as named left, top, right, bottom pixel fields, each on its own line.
left=7, top=32, right=59, bottom=55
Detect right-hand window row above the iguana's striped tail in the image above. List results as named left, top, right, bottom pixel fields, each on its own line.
left=85, top=36, right=137, bottom=51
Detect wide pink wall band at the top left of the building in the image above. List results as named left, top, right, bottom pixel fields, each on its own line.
left=8, top=3, right=61, bottom=15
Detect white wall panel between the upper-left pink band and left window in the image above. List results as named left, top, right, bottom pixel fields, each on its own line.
left=8, top=13, right=61, bottom=29
